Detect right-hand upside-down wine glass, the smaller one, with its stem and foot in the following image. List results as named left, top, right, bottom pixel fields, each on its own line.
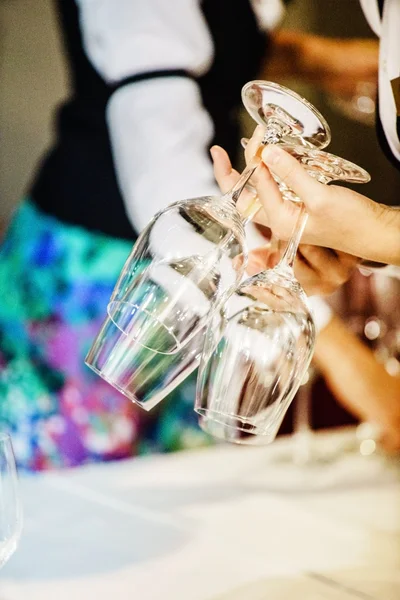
left=195, top=146, right=370, bottom=443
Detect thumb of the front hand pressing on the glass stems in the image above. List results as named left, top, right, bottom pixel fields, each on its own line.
left=262, top=145, right=326, bottom=212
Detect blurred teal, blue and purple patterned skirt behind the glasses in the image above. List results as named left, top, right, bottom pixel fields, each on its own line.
left=0, top=202, right=211, bottom=470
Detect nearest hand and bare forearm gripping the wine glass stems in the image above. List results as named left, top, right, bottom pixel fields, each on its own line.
left=236, top=127, right=400, bottom=264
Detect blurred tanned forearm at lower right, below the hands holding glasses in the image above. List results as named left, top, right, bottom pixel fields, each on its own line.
left=314, top=317, right=400, bottom=433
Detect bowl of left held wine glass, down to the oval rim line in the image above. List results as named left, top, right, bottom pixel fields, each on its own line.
left=104, top=199, right=247, bottom=354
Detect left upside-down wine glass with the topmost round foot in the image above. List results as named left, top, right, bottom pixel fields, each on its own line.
left=86, top=81, right=331, bottom=409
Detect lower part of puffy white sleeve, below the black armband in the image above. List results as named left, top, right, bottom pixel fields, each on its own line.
left=107, top=78, right=218, bottom=231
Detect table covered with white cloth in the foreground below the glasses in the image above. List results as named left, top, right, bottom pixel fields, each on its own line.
left=0, top=428, right=400, bottom=600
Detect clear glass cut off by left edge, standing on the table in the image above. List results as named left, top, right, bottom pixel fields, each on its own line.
left=0, top=432, right=22, bottom=568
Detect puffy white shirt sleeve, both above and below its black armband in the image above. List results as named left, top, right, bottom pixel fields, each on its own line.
left=77, top=0, right=218, bottom=231
